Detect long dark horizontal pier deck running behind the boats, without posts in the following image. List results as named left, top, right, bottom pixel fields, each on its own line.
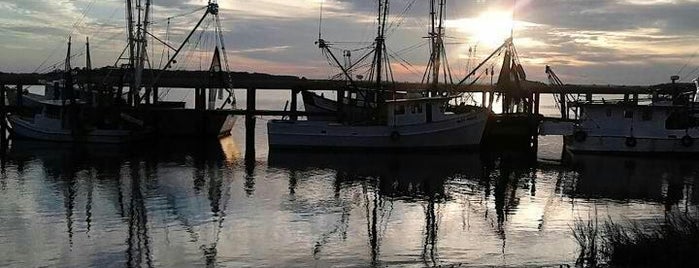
left=0, top=68, right=693, bottom=95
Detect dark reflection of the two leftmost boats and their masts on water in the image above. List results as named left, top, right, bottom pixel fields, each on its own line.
left=3, top=138, right=239, bottom=267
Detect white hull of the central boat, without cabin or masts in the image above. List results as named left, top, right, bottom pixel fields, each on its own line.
left=267, top=112, right=487, bottom=150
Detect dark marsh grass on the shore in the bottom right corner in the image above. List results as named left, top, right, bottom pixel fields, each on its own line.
left=571, top=212, right=699, bottom=267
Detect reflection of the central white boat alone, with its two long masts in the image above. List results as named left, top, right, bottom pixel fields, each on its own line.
left=268, top=151, right=482, bottom=267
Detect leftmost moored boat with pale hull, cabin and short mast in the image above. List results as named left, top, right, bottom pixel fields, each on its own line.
left=8, top=40, right=153, bottom=143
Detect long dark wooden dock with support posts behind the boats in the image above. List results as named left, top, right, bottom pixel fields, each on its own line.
left=0, top=67, right=694, bottom=159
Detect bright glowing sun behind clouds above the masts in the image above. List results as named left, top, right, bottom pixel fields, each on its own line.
left=447, top=10, right=514, bottom=46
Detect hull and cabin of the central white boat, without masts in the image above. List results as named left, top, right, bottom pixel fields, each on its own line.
left=267, top=95, right=488, bottom=150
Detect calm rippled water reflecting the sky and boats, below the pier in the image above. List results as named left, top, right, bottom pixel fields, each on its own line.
left=0, top=92, right=699, bottom=267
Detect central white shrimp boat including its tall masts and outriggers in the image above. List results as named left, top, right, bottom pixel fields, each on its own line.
left=267, top=0, right=488, bottom=150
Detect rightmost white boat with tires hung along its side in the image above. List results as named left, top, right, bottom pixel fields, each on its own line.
left=564, top=77, right=699, bottom=154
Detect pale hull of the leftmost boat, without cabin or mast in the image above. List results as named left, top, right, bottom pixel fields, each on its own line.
left=8, top=115, right=152, bottom=144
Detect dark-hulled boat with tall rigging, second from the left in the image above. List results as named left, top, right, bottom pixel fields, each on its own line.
left=117, top=0, right=236, bottom=138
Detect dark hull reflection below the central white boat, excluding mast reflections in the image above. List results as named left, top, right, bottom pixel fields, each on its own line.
left=268, top=151, right=483, bottom=201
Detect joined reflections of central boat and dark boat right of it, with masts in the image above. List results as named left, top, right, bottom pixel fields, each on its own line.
left=268, top=151, right=535, bottom=266
